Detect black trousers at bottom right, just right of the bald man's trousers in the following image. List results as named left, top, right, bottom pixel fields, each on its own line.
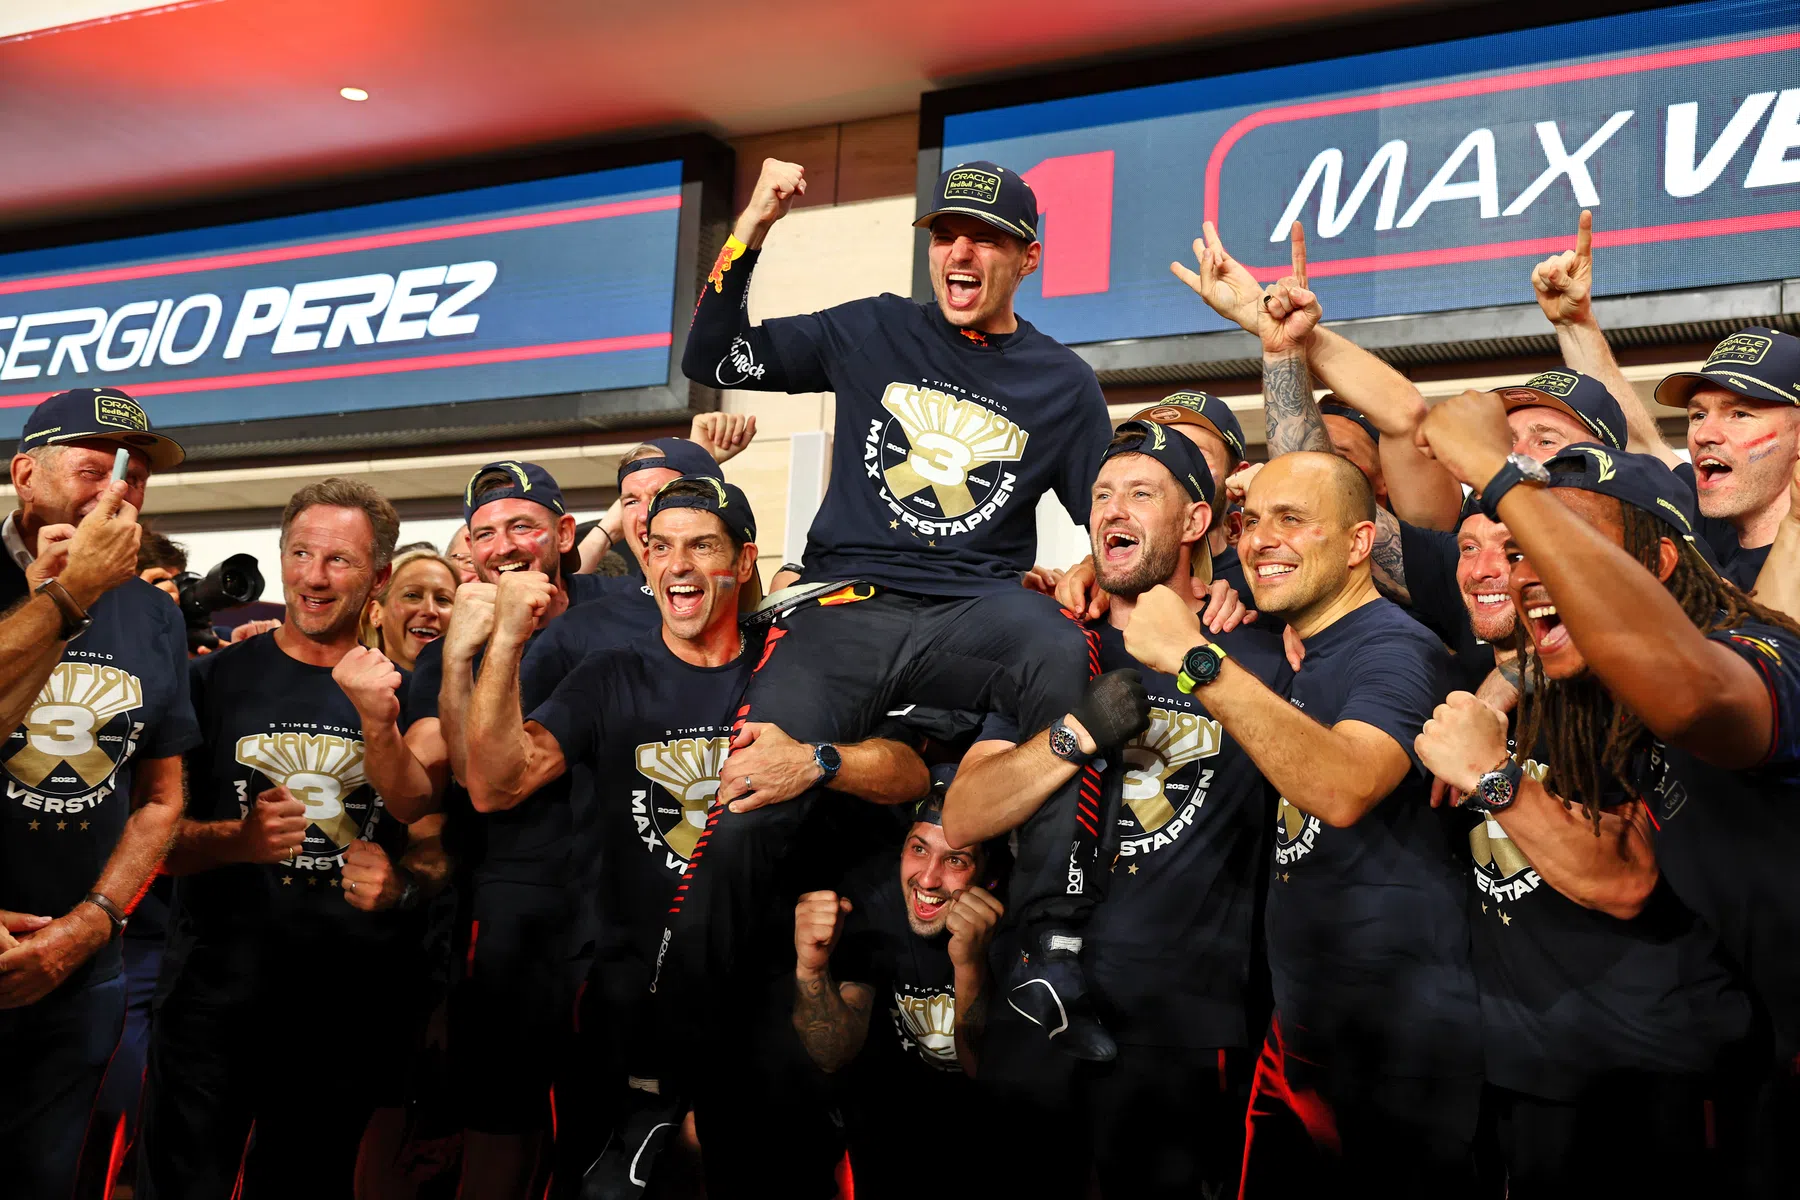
left=1487, top=1070, right=1739, bottom=1200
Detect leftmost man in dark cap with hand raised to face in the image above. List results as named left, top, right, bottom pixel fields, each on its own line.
left=0, top=389, right=198, bottom=1200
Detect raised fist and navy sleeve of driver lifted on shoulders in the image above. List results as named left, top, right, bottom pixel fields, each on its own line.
left=680, top=158, right=830, bottom=392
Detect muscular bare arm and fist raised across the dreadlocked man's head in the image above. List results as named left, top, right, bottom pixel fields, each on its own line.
left=1420, top=392, right=1773, bottom=770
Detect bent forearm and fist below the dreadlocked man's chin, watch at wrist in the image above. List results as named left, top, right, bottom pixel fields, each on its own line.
left=1413, top=691, right=1658, bottom=921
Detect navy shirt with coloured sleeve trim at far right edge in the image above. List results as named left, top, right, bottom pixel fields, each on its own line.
left=1634, top=621, right=1800, bottom=1063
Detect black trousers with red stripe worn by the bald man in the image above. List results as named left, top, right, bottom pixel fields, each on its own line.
left=1238, top=1016, right=1483, bottom=1200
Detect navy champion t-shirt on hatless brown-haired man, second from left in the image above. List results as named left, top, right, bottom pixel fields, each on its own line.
left=176, top=633, right=423, bottom=990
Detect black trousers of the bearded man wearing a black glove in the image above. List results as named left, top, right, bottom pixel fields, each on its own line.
left=979, top=1013, right=1253, bottom=1200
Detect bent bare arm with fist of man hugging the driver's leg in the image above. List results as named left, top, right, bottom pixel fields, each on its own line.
left=460, top=570, right=567, bottom=813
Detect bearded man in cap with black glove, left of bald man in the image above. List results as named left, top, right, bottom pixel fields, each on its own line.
left=947, top=421, right=1285, bottom=1196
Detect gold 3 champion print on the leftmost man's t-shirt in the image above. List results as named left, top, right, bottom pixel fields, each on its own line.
left=5, top=660, right=144, bottom=792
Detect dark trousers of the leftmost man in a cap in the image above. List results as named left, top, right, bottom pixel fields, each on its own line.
left=0, top=975, right=126, bottom=1200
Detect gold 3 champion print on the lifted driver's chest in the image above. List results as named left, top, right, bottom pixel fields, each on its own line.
left=882, top=383, right=1030, bottom=518
